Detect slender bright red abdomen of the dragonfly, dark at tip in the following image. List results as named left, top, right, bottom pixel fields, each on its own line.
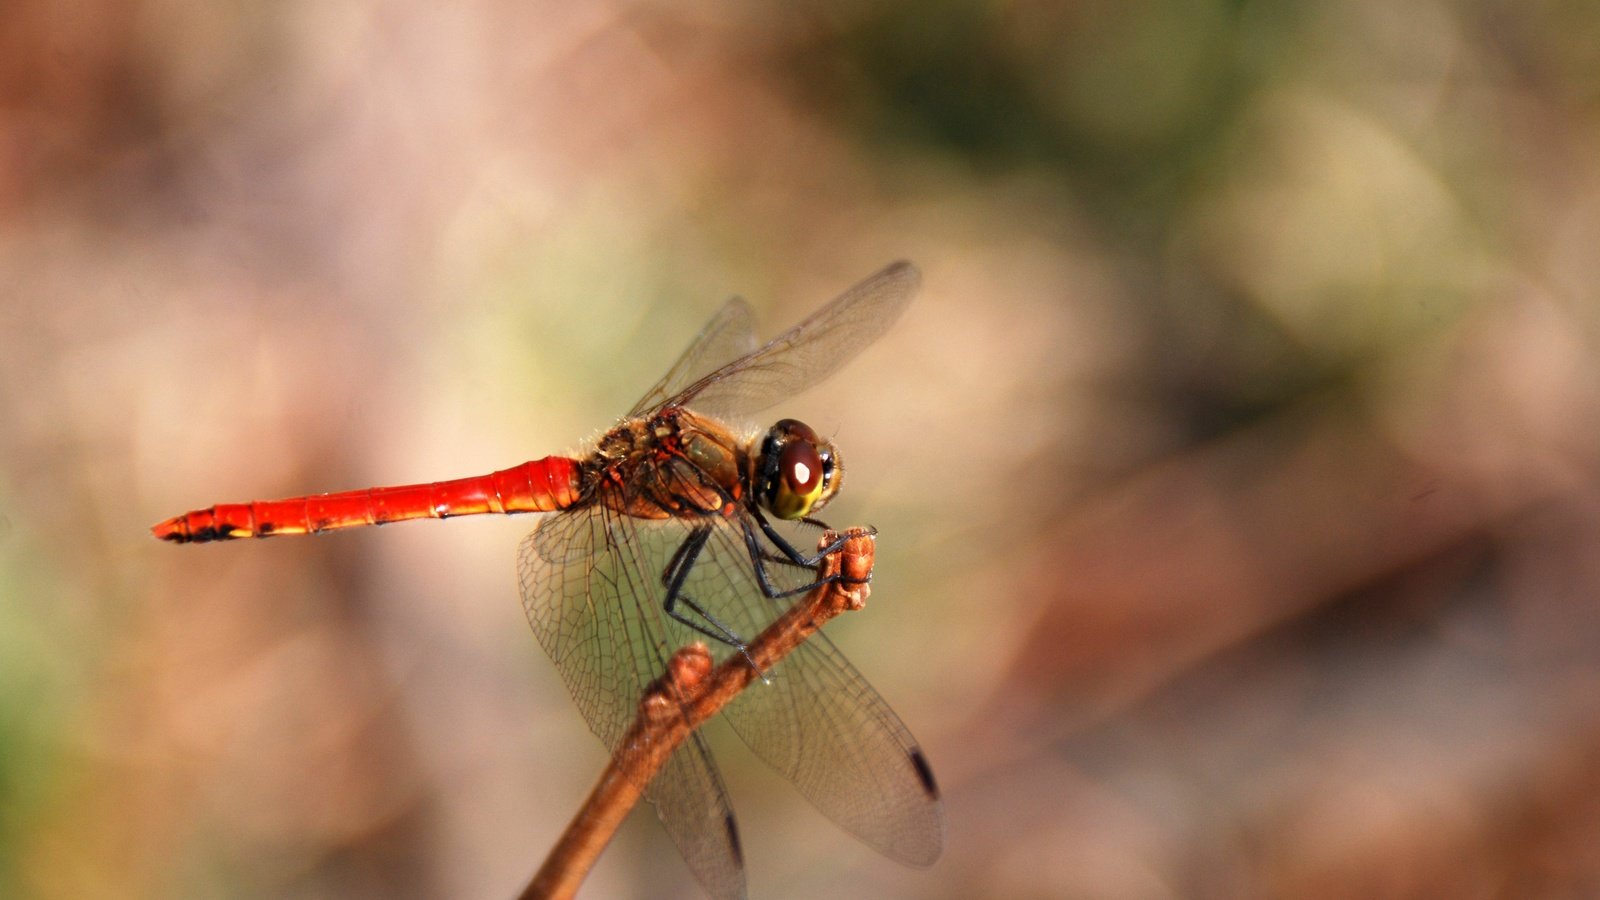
left=150, top=456, right=581, bottom=543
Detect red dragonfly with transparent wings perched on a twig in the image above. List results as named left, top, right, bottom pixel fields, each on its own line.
left=152, top=261, right=944, bottom=897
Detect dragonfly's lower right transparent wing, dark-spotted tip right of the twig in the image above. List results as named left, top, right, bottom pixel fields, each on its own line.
left=688, top=520, right=944, bottom=866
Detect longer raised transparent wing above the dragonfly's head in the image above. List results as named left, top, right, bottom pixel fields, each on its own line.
left=634, top=261, right=922, bottom=420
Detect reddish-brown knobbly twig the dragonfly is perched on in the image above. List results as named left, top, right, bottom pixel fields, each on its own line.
left=522, top=528, right=874, bottom=900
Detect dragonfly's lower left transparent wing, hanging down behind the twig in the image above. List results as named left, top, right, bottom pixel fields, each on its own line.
left=518, top=504, right=744, bottom=897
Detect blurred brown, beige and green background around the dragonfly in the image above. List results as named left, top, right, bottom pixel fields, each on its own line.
left=0, top=0, right=1600, bottom=898
